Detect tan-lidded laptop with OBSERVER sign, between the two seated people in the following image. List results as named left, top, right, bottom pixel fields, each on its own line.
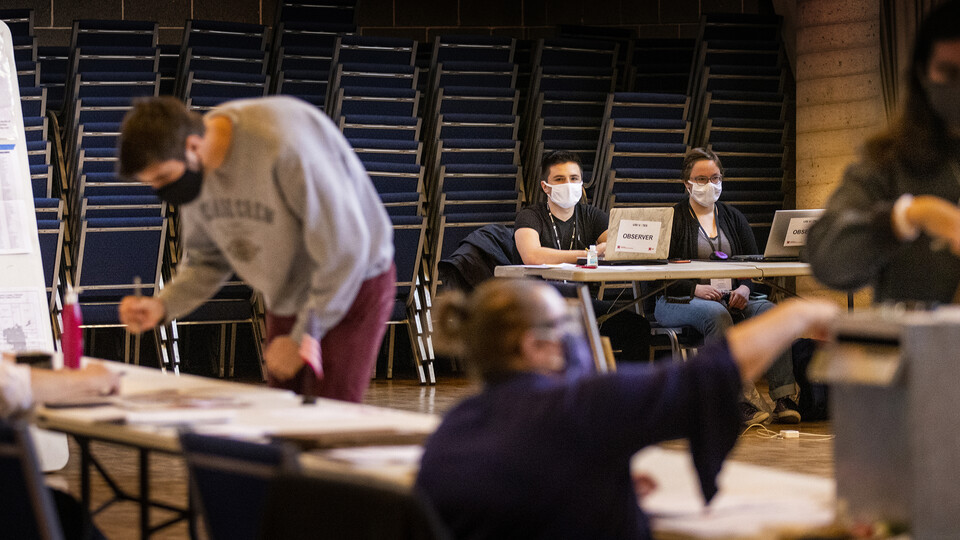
left=577, top=207, right=673, bottom=266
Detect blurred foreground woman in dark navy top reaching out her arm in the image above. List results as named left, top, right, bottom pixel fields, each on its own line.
left=416, top=279, right=837, bottom=539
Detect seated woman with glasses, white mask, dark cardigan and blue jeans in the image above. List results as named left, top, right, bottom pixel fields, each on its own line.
left=654, top=148, right=800, bottom=424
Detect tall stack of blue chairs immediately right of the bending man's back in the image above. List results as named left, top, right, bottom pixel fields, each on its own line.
left=326, top=35, right=436, bottom=384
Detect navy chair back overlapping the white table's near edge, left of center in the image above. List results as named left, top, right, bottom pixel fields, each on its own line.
left=180, top=432, right=294, bottom=540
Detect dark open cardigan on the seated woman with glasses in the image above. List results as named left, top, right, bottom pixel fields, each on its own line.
left=666, top=198, right=759, bottom=298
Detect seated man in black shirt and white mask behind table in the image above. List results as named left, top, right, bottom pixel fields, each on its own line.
left=514, top=151, right=650, bottom=361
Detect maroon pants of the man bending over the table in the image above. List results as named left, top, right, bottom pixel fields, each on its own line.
left=267, top=264, right=397, bottom=403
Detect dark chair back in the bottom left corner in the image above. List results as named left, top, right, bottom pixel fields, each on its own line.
left=0, top=420, right=63, bottom=540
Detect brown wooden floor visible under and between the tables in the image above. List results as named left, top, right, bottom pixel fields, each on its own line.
left=48, top=377, right=833, bottom=539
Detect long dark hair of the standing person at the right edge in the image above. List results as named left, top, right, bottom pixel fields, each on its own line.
left=865, top=0, right=960, bottom=175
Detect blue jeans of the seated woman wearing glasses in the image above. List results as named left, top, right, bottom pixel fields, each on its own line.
left=654, top=296, right=796, bottom=401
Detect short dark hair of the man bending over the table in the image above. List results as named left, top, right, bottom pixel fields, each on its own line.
left=118, top=96, right=203, bottom=177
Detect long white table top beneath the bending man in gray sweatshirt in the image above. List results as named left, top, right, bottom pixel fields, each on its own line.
left=36, top=359, right=440, bottom=453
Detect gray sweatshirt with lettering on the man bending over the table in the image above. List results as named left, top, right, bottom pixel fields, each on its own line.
left=160, top=96, right=393, bottom=341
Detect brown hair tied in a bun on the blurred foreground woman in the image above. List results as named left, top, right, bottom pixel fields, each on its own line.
left=433, top=278, right=558, bottom=381
